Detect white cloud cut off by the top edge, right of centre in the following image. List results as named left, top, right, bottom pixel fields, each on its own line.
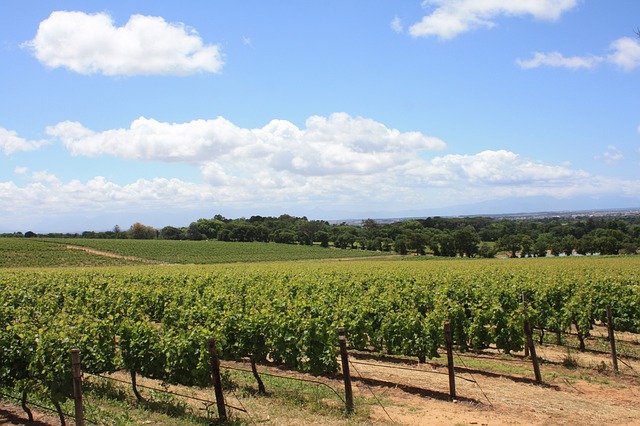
left=409, top=0, right=577, bottom=40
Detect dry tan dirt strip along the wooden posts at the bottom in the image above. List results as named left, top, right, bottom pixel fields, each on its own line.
left=5, top=352, right=640, bottom=426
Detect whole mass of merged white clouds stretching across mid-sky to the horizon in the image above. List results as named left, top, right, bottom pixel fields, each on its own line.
left=5, top=113, right=640, bottom=225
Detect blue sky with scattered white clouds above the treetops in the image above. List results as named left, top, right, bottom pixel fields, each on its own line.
left=0, top=0, right=640, bottom=232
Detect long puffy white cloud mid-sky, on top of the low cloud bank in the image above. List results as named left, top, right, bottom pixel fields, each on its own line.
left=47, top=113, right=446, bottom=176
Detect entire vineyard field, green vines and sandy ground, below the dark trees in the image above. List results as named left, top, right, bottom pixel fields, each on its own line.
left=0, top=240, right=640, bottom=425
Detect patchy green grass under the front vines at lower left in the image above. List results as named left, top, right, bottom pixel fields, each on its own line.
left=20, top=368, right=371, bottom=426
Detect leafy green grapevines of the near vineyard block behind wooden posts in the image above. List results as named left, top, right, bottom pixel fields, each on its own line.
left=0, top=258, right=640, bottom=412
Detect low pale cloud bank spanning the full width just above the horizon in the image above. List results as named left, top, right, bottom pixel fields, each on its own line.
left=0, top=150, right=640, bottom=223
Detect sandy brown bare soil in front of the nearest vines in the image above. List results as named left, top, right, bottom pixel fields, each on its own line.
left=0, top=335, right=640, bottom=426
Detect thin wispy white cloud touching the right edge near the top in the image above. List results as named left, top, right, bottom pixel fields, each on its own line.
left=516, top=37, right=640, bottom=71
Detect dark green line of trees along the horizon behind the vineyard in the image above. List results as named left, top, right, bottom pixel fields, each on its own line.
left=2, top=214, right=640, bottom=257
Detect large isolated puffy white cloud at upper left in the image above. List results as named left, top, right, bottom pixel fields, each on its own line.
left=24, top=11, right=223, bottom=76
